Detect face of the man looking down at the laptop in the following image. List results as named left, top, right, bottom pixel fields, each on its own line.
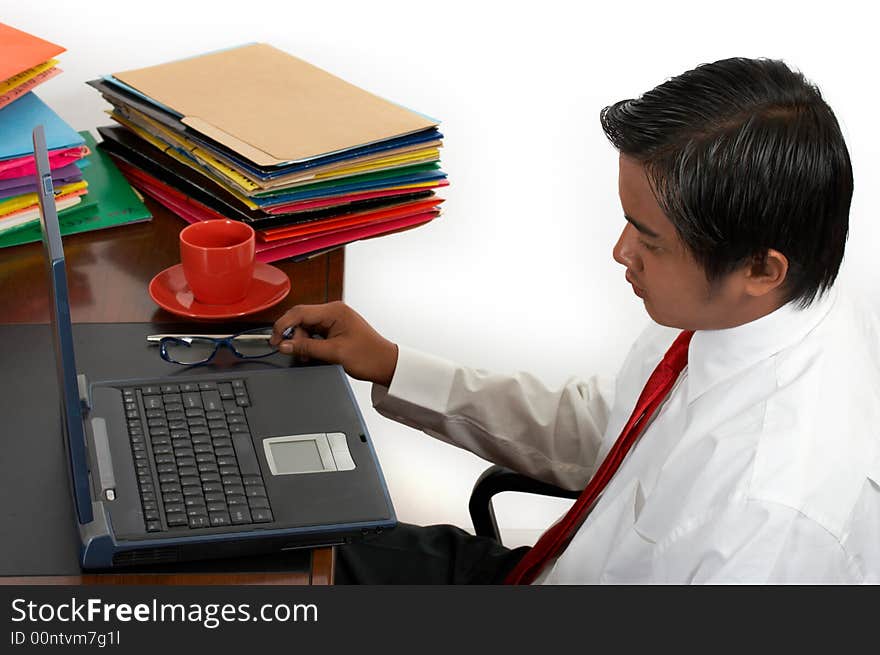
left=614, top=155, right=744, bottom=330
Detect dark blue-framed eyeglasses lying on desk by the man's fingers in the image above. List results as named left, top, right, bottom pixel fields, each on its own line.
left=155, top=327, right=278, bottom=366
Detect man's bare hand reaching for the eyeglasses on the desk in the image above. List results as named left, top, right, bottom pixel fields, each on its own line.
left=269, top=302, right=397, bottom=387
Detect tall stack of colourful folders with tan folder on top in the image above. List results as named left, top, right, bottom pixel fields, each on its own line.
left=88, top=44, right=447, bottom=262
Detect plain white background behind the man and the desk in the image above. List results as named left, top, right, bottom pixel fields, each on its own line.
left=0, top=0, right=880, bottom=543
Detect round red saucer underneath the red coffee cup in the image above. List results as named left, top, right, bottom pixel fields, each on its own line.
left=150, top=262, right=290, bottom=318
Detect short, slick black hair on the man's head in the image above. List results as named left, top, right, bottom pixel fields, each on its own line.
left=600, top=58, right=853, bottom=307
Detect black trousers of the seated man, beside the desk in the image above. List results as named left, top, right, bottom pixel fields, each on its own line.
left=334, top=523, right=529, bottom=585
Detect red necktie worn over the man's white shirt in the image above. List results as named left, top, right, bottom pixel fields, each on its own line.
left=504, top=331, right=694, bottom=584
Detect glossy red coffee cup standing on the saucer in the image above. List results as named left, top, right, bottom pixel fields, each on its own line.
left=180, top=219, right=255, bottom=305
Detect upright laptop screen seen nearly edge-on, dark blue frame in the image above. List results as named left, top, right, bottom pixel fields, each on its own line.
left=33, top=125, right=92, bottom=523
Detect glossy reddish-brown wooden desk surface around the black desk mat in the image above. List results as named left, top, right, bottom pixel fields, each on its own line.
left=0, top=198, right=345, bottom=584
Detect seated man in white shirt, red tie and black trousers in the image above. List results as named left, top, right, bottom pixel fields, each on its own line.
left=274, top=59, right=880, bottom=583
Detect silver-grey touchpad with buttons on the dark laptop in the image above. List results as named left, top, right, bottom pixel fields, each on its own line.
left=263, top=432, right=355, bottom=475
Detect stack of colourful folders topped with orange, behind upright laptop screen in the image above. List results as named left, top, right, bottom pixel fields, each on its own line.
left=0, top=23, right=89, bottom=235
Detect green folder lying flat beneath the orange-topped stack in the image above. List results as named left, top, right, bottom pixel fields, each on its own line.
left=0, top=131, right=153, bottom=248
